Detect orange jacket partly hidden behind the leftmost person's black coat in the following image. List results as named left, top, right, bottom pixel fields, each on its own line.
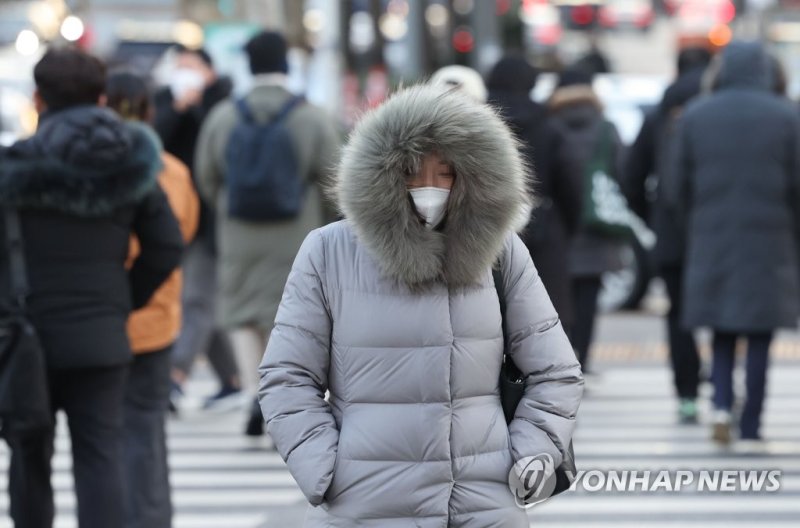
left=128, top=152, right=200, bottom=354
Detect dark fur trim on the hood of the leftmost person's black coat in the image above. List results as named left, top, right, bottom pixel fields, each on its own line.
left=0, top=122, right=162, bottom=218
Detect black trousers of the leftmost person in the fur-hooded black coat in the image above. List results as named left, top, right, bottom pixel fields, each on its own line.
left=9, top=366, right=128, bottom=528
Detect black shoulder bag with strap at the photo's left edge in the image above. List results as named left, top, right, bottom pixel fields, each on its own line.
left=0, top=208, right=53, bottom=440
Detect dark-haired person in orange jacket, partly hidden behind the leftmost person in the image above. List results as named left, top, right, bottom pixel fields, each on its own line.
left=106, top=72, right=200, bottom=528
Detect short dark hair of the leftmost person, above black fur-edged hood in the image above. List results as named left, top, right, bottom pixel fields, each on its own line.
left=33, top=48, right=106, bottom=110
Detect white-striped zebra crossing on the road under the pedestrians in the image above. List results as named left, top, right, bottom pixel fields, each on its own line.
left=0, top=361, right=800, bottom=528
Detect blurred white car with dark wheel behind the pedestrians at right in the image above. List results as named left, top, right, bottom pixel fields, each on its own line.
left=532, top=74, right=668, bottom=311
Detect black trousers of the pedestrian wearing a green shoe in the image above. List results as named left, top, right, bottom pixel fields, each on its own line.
left=661, top=266, right=700, bottom=399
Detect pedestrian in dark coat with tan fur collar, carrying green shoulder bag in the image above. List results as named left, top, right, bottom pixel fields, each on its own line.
left=548, top=69, right=623, bottom=372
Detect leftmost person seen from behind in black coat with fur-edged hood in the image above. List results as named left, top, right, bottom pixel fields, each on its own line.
left=0, top=49, right=183, bottom=528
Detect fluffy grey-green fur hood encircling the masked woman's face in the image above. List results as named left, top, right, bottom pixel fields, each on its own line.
left=335, top=85, right=532, bottom=288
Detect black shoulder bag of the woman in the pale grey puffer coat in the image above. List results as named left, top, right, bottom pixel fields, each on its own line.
left=492, top=269, right=578, bottom=497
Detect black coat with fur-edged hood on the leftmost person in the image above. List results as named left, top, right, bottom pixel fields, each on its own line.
left=0, top=107, right=183, bottom=368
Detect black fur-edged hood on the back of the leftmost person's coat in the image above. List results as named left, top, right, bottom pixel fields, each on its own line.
left=0, top=106, right=161, bottom=217
